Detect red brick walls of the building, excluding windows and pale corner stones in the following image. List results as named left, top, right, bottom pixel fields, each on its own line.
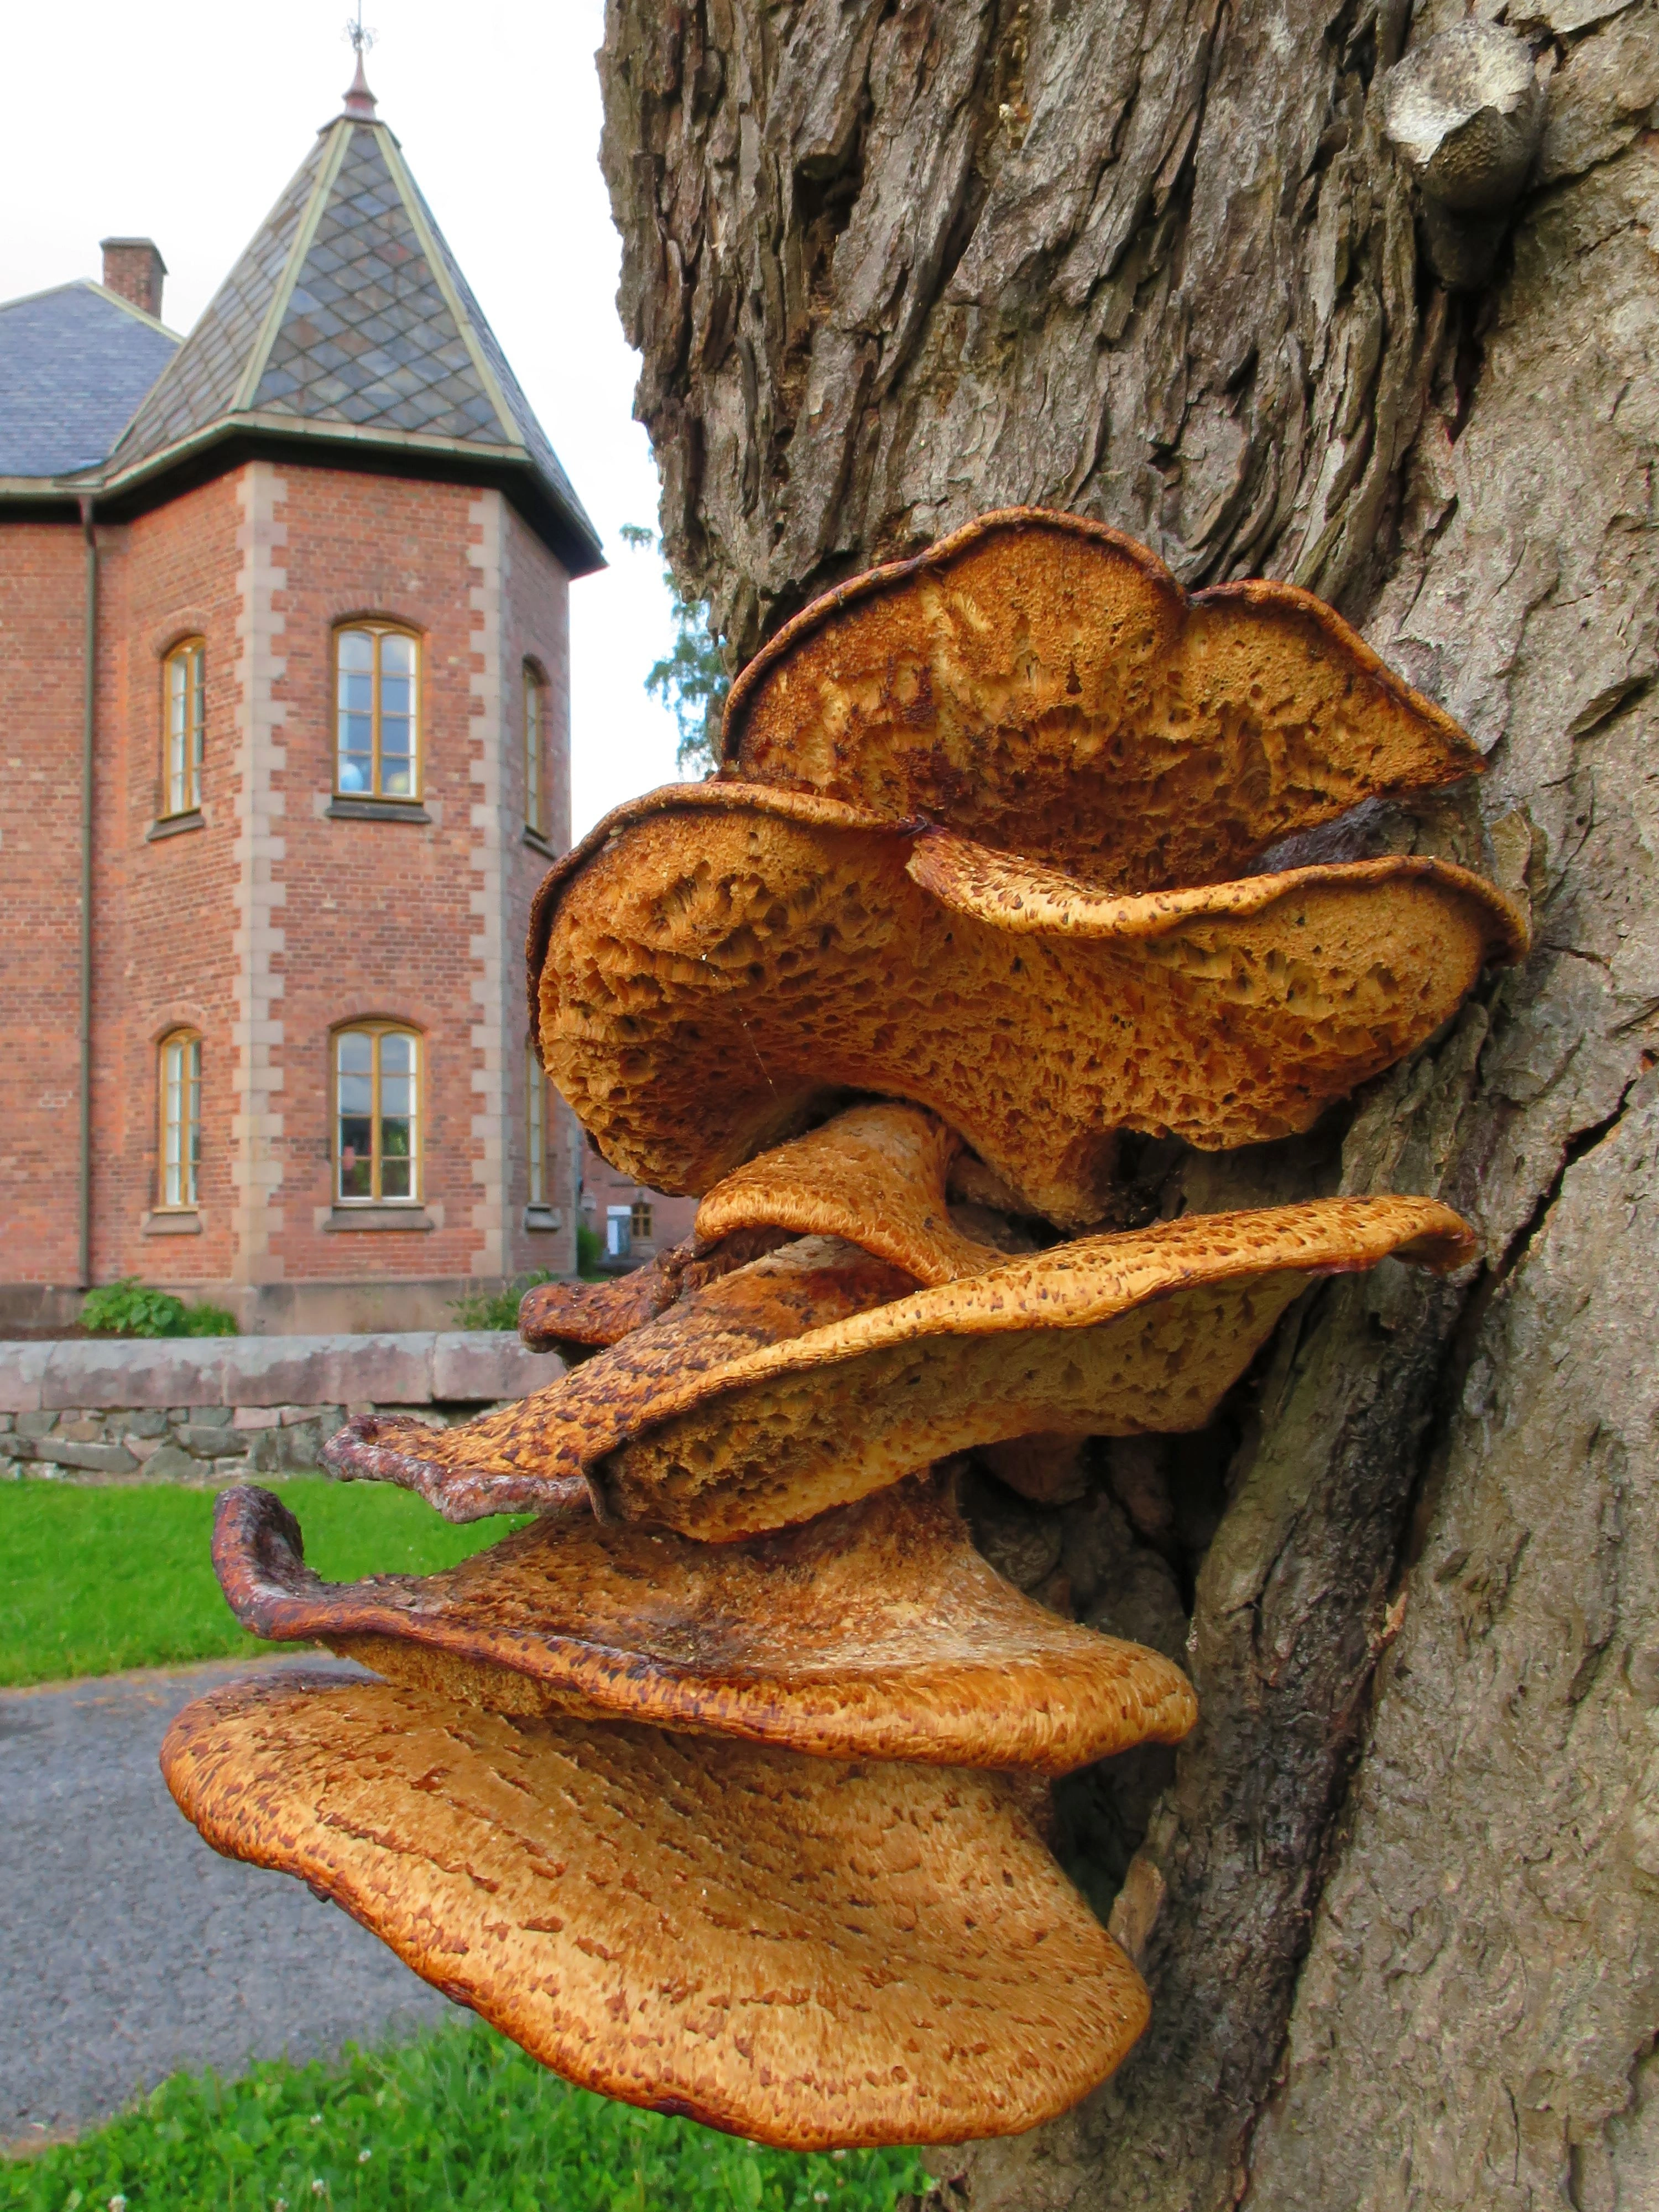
left=0, top=462, right=575, bottom=1285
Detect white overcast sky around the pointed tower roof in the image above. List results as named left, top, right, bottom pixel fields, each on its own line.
left=0, top=0, right=675, bottom=836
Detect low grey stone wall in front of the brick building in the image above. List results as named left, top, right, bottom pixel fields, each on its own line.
left=0, top=1329, right=564, bottom=1482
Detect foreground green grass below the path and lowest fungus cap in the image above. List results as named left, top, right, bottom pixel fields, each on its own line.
left=0, top=2022, right=927, bottom=2212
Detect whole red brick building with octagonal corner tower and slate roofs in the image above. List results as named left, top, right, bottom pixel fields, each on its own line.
left=0, top=69, right=602, bottom=1329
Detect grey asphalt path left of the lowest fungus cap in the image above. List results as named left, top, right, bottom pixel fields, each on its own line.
left=0, top=1659, right=451, bottom=2146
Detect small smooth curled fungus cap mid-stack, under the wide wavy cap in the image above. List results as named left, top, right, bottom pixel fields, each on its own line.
left=695, top=1104, right=1002, bottom=1285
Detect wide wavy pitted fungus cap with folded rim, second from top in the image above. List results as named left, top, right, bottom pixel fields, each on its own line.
left=531, top=783, right=1524, bottom=1228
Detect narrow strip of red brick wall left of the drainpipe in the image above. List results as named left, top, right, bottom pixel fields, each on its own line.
left=0, top=522, right=84, bottom=1283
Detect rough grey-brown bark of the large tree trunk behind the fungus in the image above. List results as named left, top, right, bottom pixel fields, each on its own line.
left=602, top=0, right=1659, bottom=2212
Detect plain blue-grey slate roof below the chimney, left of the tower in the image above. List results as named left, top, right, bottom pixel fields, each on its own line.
left=0, top=281, right=179, bottom=478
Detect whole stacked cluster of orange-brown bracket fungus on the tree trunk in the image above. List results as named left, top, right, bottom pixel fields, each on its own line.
left=164, top=509, right=1526, bottom=2150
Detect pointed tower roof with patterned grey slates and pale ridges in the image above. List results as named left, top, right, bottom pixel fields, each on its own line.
left=102, top=80, right=604, bottom=575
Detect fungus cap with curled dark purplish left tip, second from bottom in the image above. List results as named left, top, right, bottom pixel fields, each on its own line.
left=212, top=1471, right=1197, bottom=1774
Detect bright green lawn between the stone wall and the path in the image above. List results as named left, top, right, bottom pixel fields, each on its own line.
left=0, top=1475, right=520, bottom=1688
